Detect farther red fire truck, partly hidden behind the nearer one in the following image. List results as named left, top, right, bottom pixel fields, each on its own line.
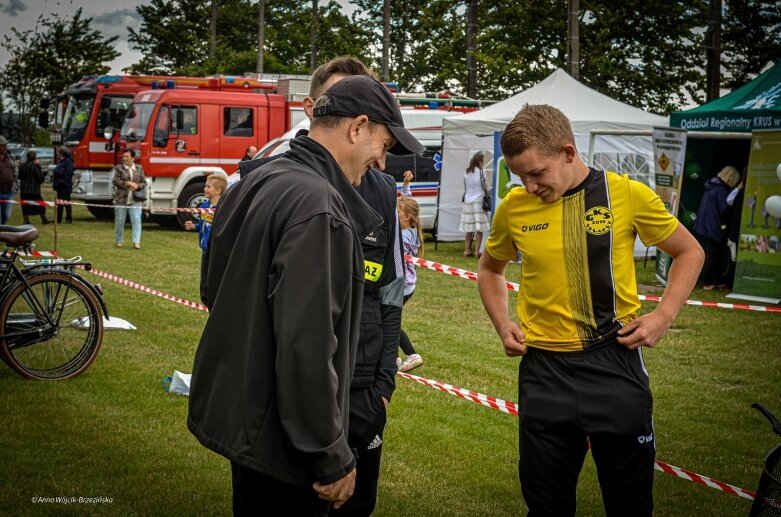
left=39, top=75, right=275, bottom=216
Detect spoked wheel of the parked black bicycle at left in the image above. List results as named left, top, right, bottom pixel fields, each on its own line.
left=0, top=272, right=103, bottom=380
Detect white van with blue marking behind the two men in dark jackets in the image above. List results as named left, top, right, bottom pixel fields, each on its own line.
left=235, top=108, right=462, bottom=233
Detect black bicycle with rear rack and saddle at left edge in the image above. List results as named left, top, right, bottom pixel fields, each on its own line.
left=0, top=225, right=108, bottom=380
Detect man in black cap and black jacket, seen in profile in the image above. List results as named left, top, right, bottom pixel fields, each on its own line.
left=188, top=77, right=424, bottom=515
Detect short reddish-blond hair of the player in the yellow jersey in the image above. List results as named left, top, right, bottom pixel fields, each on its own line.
left=501, top=104, right=575, bottom=158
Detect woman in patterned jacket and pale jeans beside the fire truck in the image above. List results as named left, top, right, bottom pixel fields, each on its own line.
left=114, top=149, right=146, bottom=250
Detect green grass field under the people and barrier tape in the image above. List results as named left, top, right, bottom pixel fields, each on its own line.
left=0, top=200, right=781, bottom=516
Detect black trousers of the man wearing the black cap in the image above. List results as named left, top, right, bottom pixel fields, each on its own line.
left=231, top=462, right=331, bottom=517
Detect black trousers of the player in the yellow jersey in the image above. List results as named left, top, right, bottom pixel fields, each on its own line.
left=518, top=339, right=656, bottom=517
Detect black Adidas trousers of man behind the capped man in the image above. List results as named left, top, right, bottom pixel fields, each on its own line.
left=331, top=388, right=387, bottom=517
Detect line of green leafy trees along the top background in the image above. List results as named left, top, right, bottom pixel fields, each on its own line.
left=0, top=0, right=781, bottom=145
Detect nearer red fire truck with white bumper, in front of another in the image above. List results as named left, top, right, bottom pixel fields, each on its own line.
left=116, top=88, right=290, bottom=226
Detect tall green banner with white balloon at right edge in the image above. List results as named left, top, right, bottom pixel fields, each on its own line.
left=728, top=131, right=781, bottom=303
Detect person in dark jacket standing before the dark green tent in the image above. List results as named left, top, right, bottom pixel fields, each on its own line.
left=694, top=165, right=740, bottom=291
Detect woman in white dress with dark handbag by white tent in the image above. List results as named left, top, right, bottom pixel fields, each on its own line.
left=459, top=151, right=491, bottom=258
